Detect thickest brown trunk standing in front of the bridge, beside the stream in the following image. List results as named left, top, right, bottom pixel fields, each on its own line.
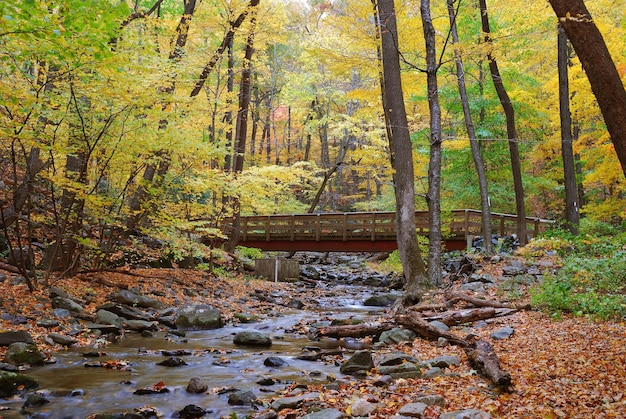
left=378, top=0, right=430, bottom=301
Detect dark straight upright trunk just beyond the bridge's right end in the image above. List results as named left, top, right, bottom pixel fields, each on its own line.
left=557, top=25, right=580, bottom=235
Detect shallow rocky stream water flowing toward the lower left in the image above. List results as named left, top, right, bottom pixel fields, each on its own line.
left=0, top=285, right=388, bottom=419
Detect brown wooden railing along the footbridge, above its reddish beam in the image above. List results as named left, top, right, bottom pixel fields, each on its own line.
left=224, top=209, right=553, bottom=246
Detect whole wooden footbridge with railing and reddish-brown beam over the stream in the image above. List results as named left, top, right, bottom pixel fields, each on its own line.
left=224, top=209, right=554, bottom=252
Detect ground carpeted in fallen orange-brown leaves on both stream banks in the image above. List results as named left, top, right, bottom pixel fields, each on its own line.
left=0, top=256, right=626, bottom=419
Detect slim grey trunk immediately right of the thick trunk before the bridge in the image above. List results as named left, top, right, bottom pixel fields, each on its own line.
left=420, top=0, right=441, bottom=286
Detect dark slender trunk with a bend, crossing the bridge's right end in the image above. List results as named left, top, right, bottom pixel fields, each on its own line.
left=479, top=0, right=527, bottom=245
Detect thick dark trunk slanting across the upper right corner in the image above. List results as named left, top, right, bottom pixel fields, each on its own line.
left=549, top=0, right=626, bottom=176
